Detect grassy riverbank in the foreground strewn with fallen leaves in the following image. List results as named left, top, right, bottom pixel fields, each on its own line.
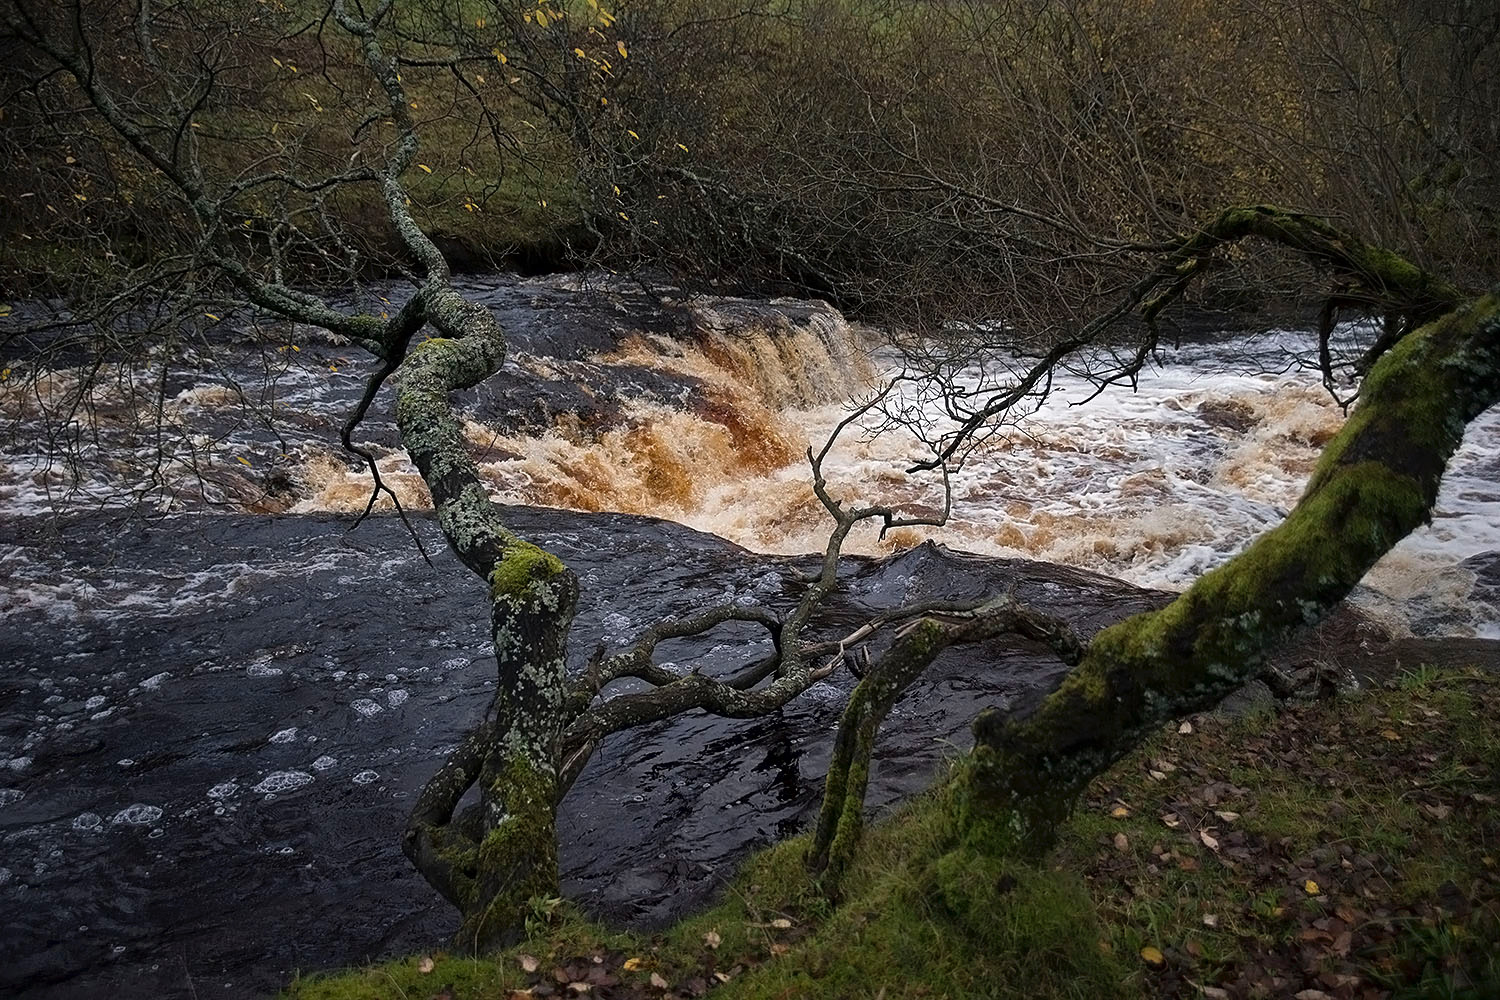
left=290, top=669, right=1500, bottom=1000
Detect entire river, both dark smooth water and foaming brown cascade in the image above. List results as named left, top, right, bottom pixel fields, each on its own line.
left=0, top=269, right=1500, bottom=997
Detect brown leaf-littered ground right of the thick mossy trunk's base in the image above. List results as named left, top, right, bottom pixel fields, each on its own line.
left=1065, top=675, right=1500, bottom=1000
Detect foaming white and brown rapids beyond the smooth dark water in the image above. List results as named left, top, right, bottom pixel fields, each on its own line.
left=0, top=277, right=1500, bottom=636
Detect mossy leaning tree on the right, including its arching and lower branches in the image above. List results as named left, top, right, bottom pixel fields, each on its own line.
left=810, top=205, right=1500, bottom=869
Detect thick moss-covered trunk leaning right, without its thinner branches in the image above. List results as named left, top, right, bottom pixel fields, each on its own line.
left=960, top=289, right=1500, bottom=852
